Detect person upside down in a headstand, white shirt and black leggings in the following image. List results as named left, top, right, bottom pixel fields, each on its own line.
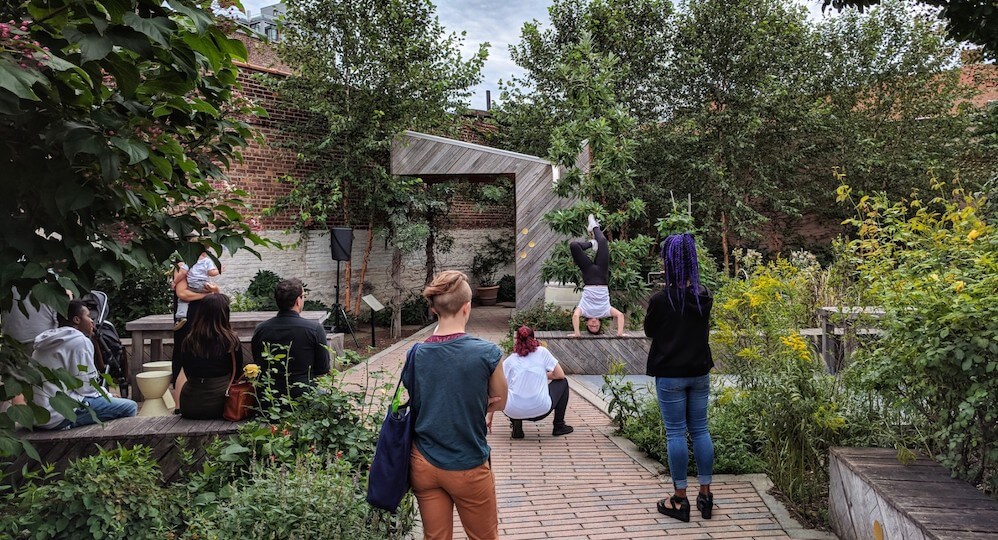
left=568, top=214, right=627, bottom=337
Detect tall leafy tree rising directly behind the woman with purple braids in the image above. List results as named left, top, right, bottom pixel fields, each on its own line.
left=638, top=0, right=822, bottom=270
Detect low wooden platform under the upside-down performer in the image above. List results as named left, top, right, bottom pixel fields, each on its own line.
left=535, top=331, right=651, bottom=375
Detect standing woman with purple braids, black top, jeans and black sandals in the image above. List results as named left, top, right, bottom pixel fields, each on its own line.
left=644, top=233, right=714, bottom=521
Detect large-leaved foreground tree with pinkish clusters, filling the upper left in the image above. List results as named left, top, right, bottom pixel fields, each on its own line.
left=0, top=0, right=272, bottom=454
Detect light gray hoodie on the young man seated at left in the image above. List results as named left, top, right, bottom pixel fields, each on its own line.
left=31, top=326, right=101, bottom=429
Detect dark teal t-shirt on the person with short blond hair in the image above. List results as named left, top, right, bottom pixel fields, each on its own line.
left=402, top=335, right=502, bottom=471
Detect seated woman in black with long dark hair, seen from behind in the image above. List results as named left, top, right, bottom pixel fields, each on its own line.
left=175, top=294, right=243, bottom=420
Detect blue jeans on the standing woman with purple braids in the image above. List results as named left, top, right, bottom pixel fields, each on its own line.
left=655, top=375, right=714, bottom=489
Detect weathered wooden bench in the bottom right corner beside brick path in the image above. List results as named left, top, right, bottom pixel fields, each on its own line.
left=828, top=448, right=998, bottom=540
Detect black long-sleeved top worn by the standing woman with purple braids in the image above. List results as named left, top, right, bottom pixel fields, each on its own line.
left=644, top=287, right=714, bottom=377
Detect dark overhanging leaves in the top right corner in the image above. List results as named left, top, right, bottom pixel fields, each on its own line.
left=822, top=0, right=998, bottom=58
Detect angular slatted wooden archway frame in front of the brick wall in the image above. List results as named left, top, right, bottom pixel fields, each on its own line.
left=391, top=131, right=571, bottom=308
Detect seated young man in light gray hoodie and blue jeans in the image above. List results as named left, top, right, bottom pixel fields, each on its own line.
left=31, top=300, right=138, bottom=429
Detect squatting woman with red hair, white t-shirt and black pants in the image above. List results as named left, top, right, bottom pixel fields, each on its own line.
left=488, top=326, right=575, bottom=439
